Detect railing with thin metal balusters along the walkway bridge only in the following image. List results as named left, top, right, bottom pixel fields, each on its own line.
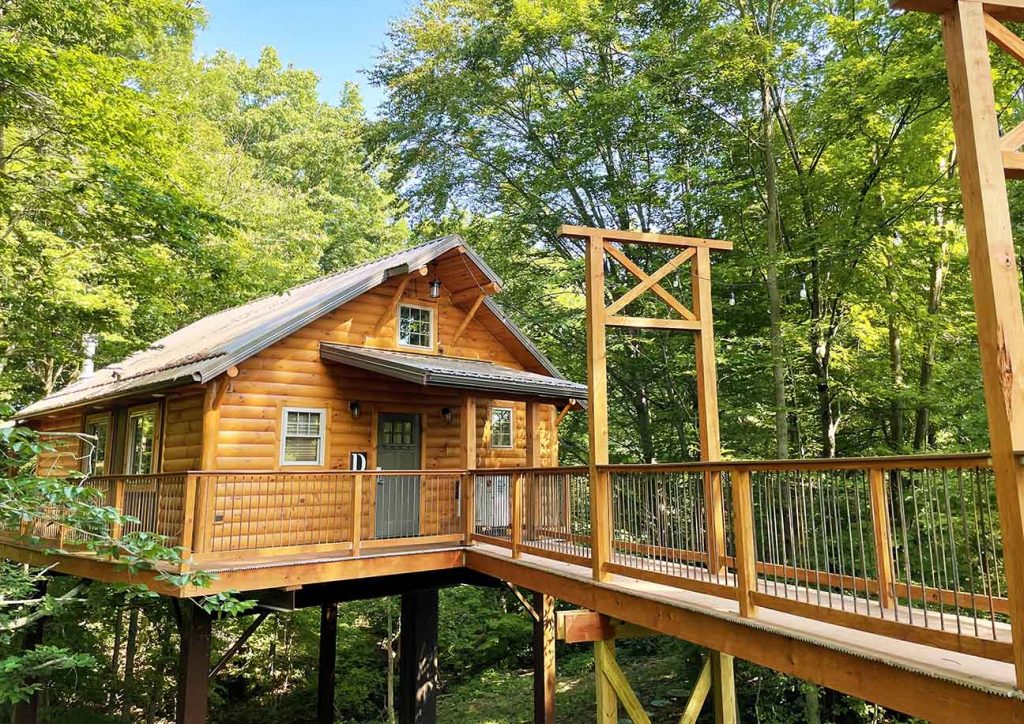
left=483, top=455, right=1013, bottom=662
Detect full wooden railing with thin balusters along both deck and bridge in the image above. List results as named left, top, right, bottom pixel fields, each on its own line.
left=14, top=455, right=1012, bottom=662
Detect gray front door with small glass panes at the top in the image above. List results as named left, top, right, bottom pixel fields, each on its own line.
left=377, top=414, right=421, bottom=538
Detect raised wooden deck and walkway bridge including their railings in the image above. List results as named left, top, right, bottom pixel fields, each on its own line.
left=9, top=455, right=1024, bottom=724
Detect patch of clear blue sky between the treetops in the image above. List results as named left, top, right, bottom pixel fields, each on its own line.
left=196, top=0, right=414, bottom=115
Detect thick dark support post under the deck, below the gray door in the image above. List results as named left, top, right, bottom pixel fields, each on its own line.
left=398, top=589, right=437, bottom=724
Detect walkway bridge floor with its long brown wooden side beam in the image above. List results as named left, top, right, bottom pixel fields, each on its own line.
left=466, top=544, right=1024, bottom=722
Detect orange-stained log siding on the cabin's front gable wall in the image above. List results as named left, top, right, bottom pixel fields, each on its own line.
left=208, top=278, right=557, bottom=540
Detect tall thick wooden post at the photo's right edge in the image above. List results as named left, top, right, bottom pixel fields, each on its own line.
left=942, top=0, right=1024, bottom=688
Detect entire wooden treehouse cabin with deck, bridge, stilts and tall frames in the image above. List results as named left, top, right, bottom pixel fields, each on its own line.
left=9, top=0, right=1024, bottom=724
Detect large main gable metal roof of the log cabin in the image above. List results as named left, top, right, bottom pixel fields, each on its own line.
left=15, top=235, right=577, bottom=420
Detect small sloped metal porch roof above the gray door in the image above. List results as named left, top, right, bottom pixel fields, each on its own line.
left=321, top=342, right=587, bottom=399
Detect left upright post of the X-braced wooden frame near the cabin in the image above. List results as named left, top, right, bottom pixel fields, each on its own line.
left=587, top=236, right=611, bottom=581
